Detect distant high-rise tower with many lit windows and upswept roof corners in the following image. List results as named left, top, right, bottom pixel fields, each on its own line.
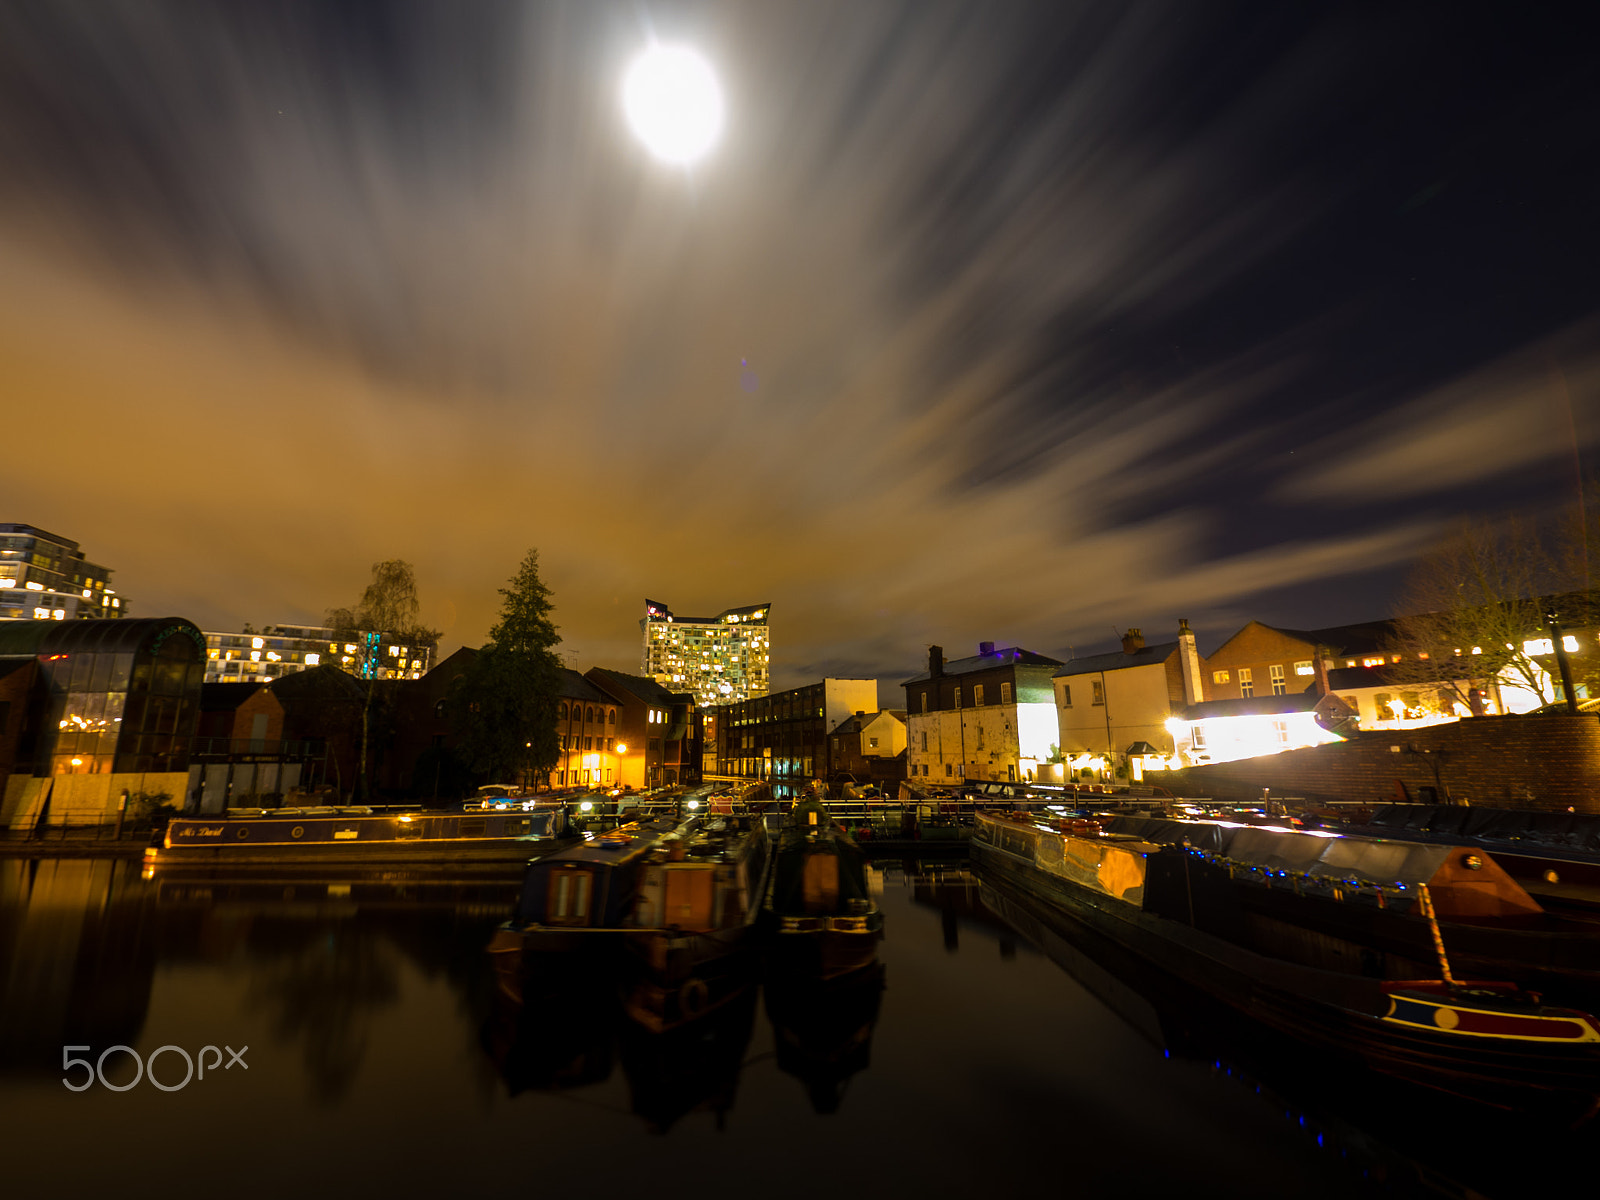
left=638, top=600, right=771, bottom=704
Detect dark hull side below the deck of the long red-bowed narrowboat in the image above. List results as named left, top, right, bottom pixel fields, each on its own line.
left=973, top=840, right=1600, bottom=1118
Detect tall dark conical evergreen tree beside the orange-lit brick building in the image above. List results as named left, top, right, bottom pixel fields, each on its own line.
left=451, top=550, right=562, bottom=787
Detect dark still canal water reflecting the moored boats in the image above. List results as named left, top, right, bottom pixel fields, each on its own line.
left=0, top=859, right=1597, bottom=1200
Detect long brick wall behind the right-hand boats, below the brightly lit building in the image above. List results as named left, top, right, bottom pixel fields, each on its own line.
left=1171, top=714, right=1600, bottom=813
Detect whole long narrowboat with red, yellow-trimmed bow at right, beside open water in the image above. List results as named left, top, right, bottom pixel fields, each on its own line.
left=973, top=813, right=1600, bottom=1120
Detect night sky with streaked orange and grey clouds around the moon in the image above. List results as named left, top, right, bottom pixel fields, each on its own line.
left=0, top=0, right=1600, bottom=701
